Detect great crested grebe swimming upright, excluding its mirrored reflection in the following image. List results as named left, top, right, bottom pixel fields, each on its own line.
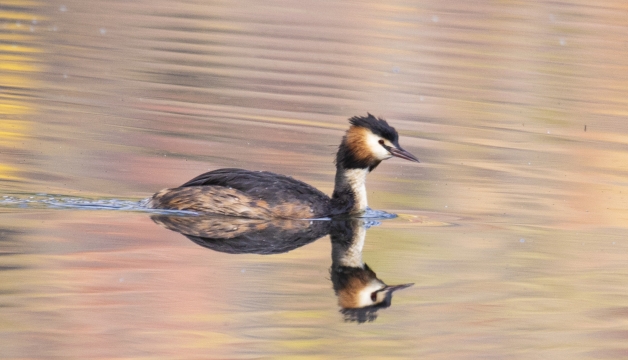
left=147, top=114, right=419, bottom=219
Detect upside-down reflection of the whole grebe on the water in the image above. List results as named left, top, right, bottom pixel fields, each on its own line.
left=152, top=215, right=413, bottom=323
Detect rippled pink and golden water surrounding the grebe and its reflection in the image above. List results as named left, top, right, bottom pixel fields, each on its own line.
left=0, top=0, right=628, bottom=359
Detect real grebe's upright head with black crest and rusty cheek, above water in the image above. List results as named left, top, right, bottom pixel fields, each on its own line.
left=336, top=114, right=419, bottom=171
